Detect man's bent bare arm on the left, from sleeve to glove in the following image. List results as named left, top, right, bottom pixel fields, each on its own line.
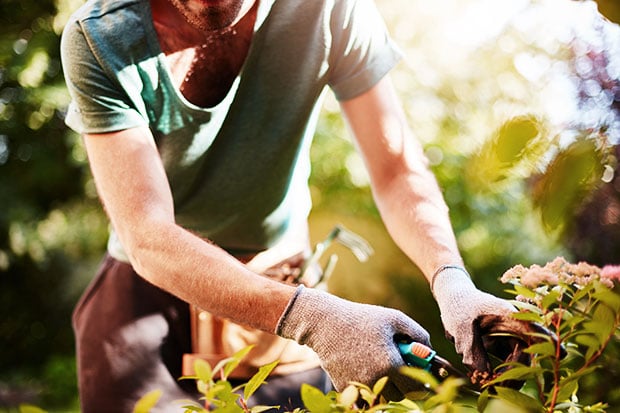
left=84, top=128, right=294, bottom=332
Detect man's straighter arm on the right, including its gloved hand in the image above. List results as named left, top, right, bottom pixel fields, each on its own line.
left=342, top=78, right=528, bottom=371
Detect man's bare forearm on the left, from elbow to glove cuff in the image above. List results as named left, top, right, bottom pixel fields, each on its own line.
left=122, top=219, right=294, bottom=332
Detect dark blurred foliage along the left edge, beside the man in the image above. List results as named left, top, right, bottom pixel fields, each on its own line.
left=0, top=0, right=108, bottom=407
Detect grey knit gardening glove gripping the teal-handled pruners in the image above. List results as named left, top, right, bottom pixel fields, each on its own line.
left=276, top=286, right=430, bottom=400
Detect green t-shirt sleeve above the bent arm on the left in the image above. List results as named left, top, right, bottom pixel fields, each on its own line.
left=60, top=21, right=148, bottom=133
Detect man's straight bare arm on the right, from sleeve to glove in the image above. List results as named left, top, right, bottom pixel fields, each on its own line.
left=342, top=77, right=463, bottom=281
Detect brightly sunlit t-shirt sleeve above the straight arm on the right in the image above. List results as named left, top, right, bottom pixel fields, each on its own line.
left=328, top=0, right=402, bottom=100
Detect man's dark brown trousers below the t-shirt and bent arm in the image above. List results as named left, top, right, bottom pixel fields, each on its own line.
left=73, top=255, right=331, bottom=413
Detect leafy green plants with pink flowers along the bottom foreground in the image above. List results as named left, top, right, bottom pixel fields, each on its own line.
left=123, top=258, right=620, bottom=413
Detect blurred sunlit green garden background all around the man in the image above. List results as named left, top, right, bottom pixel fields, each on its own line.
left=0, top=0, right=620, bottom=411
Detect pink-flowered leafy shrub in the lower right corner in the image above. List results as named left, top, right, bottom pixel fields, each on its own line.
left=488, top=258, right=620, bottom=412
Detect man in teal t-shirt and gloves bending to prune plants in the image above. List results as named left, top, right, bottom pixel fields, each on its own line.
left=62, top=0, right=513, bottom=412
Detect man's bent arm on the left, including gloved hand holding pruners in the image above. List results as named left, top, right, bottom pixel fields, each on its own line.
left=84, top=124, right=429, bottom=399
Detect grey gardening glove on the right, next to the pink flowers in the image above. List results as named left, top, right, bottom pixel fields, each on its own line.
left=431, top=266, right=557, bottom=388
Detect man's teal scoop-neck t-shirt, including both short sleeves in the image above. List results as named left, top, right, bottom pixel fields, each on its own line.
left=61, top=0, right=401, bottom=257
